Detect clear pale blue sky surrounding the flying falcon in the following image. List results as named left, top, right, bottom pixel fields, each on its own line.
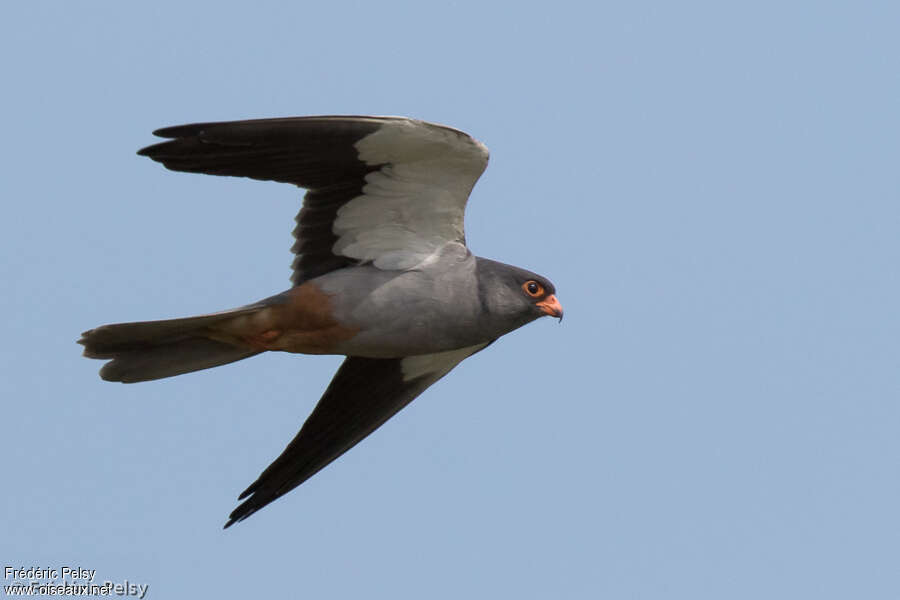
left=0, top=1, right=900, bottom=600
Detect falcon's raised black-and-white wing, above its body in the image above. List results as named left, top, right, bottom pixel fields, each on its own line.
left=138, top=116, right=488, bottom=285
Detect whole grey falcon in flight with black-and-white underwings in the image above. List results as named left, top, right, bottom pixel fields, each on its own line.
left=79, top=116, right=563, bottom=528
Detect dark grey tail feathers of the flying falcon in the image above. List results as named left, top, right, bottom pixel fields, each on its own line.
left=78, top=306, right=261, bottom=383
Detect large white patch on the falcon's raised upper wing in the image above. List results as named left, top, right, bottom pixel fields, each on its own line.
left=333, top=119, right=488, bottom=270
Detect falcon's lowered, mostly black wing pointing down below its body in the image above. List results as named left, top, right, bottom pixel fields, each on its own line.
left=225, top=342, right=489, bottom=528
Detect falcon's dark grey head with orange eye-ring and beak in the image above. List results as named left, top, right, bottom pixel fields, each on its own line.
left=476, top=258, right=563, bottom=335
